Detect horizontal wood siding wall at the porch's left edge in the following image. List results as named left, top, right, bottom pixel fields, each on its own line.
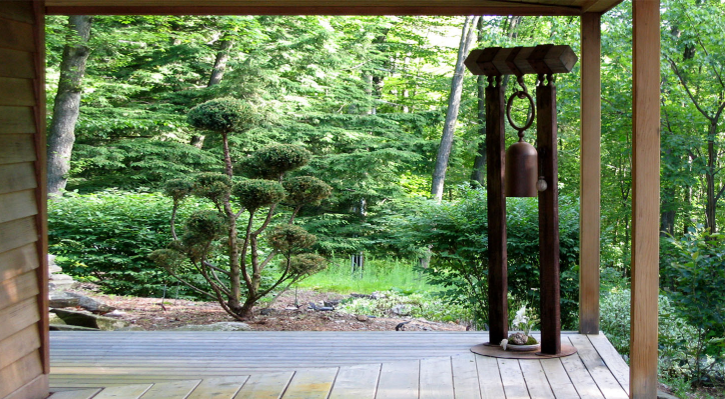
left=0, top=0, right=49, bottom=399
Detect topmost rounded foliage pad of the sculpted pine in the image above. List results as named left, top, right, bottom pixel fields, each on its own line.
left=187, top=97, right=256, bottom=133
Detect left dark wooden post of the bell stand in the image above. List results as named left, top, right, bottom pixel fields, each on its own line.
left=486, top=76, right=508, bottom=345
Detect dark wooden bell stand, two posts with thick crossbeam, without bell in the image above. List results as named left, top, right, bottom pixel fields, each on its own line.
left=465, top=44, right=577, bottom=356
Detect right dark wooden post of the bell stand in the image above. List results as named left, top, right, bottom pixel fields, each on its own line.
left=536, top=75, right=561, bottom=355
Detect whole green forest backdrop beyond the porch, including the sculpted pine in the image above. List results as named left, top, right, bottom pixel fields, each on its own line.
left=46, top=0, right=725, bottom=397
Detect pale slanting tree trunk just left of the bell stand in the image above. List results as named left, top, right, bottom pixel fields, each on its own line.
left=431, top=16, right=479, bottom=202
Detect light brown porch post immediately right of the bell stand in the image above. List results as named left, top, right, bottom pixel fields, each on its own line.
left=579, top=14, right=602, bottom=334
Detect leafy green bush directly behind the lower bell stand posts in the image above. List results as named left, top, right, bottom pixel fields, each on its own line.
left=408, top=187, right=579, bottom=329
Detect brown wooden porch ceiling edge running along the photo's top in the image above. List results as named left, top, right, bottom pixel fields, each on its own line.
left=45, top=0, right=622, bottom=15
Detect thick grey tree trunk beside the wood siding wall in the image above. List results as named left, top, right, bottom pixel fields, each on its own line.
left=47, top=15, right=92, bottom=194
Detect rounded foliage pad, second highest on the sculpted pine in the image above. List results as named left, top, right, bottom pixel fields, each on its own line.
left=243, top=144, right=312, bottom=180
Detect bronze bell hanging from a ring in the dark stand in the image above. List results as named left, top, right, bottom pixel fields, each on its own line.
left=504, top=141, right=538, bottom=197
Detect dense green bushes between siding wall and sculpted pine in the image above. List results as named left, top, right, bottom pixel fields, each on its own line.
left=48, top=191, right=207, bottom=296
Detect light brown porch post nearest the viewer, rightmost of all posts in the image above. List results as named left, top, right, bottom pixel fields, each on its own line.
left=629, top=0, right=660, bottom=399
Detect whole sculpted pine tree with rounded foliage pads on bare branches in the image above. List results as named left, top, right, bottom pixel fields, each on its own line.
left=151, top=98, right=332, bottom=320
